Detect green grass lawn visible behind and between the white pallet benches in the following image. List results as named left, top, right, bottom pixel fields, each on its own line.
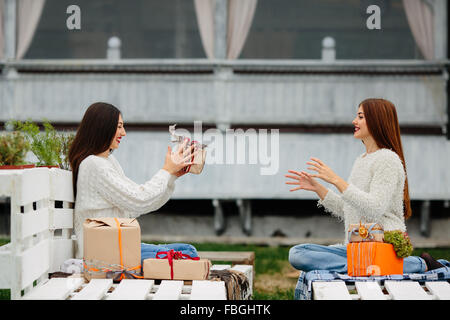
left=0, top=239, right=450, bottom=300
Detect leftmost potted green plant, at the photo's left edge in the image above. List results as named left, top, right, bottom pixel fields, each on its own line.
left=0, top=131, right=35, bottom=169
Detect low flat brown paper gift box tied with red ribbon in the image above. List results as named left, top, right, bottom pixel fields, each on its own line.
left=143, top=258, right=211, bottom=280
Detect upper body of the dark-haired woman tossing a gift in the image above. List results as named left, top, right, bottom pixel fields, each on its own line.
left=69, top=102, right=195, bottom=258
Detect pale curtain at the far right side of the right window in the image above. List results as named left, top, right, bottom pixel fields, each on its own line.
left=403, top=0, right=434, bottom=60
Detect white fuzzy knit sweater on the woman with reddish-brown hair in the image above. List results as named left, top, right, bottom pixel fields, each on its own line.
left=318, top=149, right=406, bottom=243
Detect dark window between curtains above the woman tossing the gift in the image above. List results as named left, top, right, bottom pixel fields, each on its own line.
left=24, top=0, right=205, bottom=59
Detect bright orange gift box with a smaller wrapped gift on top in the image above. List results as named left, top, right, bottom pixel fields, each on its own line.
left=347, top=223, right=403, bottom=277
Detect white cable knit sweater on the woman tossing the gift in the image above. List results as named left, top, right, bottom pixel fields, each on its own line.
left=74, top=155, right=177, bottom=258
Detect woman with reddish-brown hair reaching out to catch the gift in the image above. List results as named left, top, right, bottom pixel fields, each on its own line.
left=286, top=99, right=442, bottom=273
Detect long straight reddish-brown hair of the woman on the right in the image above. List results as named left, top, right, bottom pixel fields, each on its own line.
left=360, top=99, right=412, bottom=219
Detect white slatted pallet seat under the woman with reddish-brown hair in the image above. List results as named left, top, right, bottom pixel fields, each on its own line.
left=312, top=280, right=450, bottom=300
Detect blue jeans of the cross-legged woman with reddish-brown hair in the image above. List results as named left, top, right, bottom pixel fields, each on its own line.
left=289, top=243, right=426, bottom=273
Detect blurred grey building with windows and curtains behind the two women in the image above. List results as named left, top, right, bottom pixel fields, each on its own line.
left=0, top=0, right=450, bottom=246
